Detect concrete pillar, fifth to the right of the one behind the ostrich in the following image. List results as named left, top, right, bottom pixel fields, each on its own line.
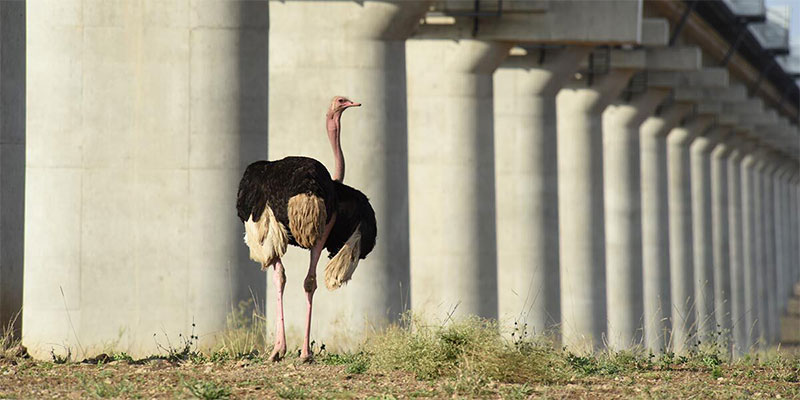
left=639, top=103, right=691, bottom=352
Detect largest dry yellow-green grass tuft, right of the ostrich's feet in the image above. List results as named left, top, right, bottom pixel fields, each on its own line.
left=364, top=315, right=569, bottom=384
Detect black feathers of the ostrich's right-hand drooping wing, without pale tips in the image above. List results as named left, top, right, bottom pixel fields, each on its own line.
left=325, top=181, right=378, bottom=259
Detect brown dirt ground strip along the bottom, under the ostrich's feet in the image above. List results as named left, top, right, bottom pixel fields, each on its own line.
left=0, top=357, right=800, bottom=399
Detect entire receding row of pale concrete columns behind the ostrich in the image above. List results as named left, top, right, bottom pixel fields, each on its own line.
left=18, top=1, right=799, bottom=354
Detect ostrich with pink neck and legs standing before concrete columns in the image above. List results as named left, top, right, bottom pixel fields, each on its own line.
left=236, top=96, right=377, bottom=362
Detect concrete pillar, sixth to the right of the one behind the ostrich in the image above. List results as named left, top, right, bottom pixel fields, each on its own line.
left=667, top=116, right=711, bottom=354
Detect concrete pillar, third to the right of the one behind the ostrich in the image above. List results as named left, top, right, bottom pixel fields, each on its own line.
left=556, top=70, right=633, bottom=350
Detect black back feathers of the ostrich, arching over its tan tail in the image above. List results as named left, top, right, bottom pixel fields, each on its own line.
left=236, top=157, right=337, bottom=246
